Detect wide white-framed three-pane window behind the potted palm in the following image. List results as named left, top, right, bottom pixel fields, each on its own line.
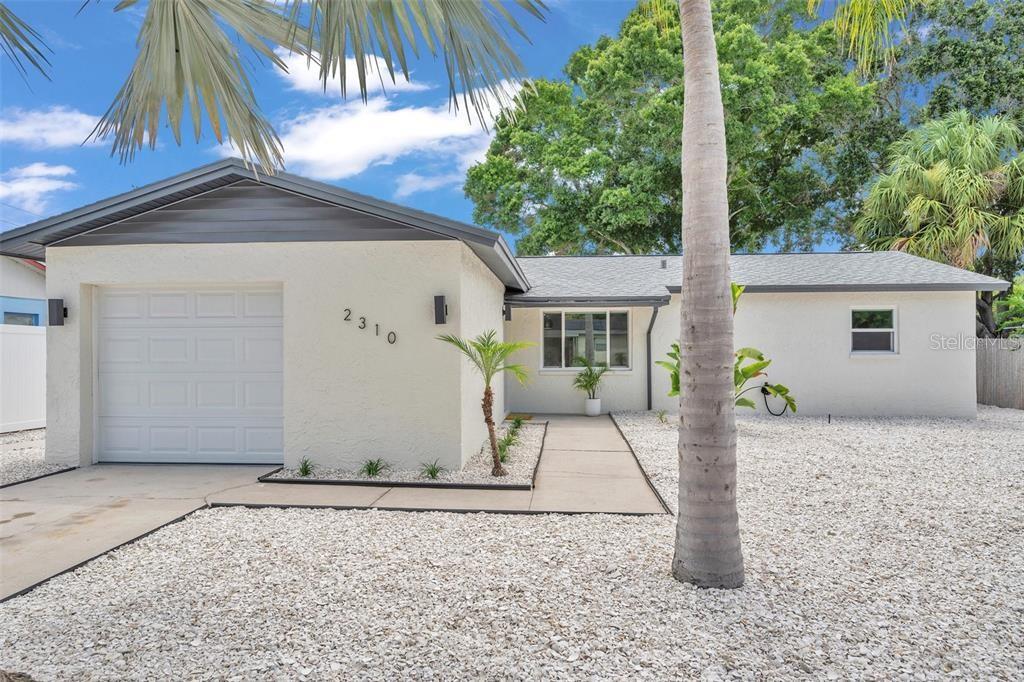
left=541, top=309, right=630, bottom=370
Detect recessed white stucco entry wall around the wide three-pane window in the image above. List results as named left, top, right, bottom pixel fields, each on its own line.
left=505, top=308, right=650, bottom=414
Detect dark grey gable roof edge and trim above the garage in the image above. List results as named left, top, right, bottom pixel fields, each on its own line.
left=0, top=159, right=529, bottom=291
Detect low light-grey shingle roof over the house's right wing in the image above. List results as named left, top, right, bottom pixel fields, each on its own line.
left=507, top=251, right=1010, bottom=305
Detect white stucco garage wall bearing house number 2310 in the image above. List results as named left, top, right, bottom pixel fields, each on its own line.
left=46, top=241, right=503, bottom=468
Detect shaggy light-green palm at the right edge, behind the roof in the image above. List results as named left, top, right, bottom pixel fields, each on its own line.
left=854, top=111, right=1024, bottom=337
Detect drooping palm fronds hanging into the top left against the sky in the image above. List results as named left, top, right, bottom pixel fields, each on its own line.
left=0, top=0, right=544, bottom=172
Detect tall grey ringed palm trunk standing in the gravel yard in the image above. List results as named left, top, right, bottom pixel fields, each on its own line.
left=672, top=0, right=743, bottom=588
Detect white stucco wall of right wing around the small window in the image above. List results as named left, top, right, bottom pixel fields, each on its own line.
left=653, top=292, right=977, bottom=417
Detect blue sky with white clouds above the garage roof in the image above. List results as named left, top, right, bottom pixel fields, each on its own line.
left=0, top=0, right=634, bottom=246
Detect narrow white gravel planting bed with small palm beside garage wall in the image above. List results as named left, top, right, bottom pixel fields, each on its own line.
left=269, top=422, right=546, bottom=485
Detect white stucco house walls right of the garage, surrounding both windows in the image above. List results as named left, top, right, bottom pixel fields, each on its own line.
left=505, top=292, right=977, bottom=417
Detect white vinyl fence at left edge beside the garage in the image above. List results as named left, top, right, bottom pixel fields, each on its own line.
left=0, top=325, right=46, bottom=433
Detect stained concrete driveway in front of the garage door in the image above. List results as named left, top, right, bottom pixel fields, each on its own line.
left=0, top=464, right=273, bottom=599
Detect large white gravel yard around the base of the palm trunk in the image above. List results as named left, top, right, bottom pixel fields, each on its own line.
left=0, top=409, right=1024, bottom=680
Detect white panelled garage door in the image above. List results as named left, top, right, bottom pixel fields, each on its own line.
left=96, top=286, right=284, bottom=463
